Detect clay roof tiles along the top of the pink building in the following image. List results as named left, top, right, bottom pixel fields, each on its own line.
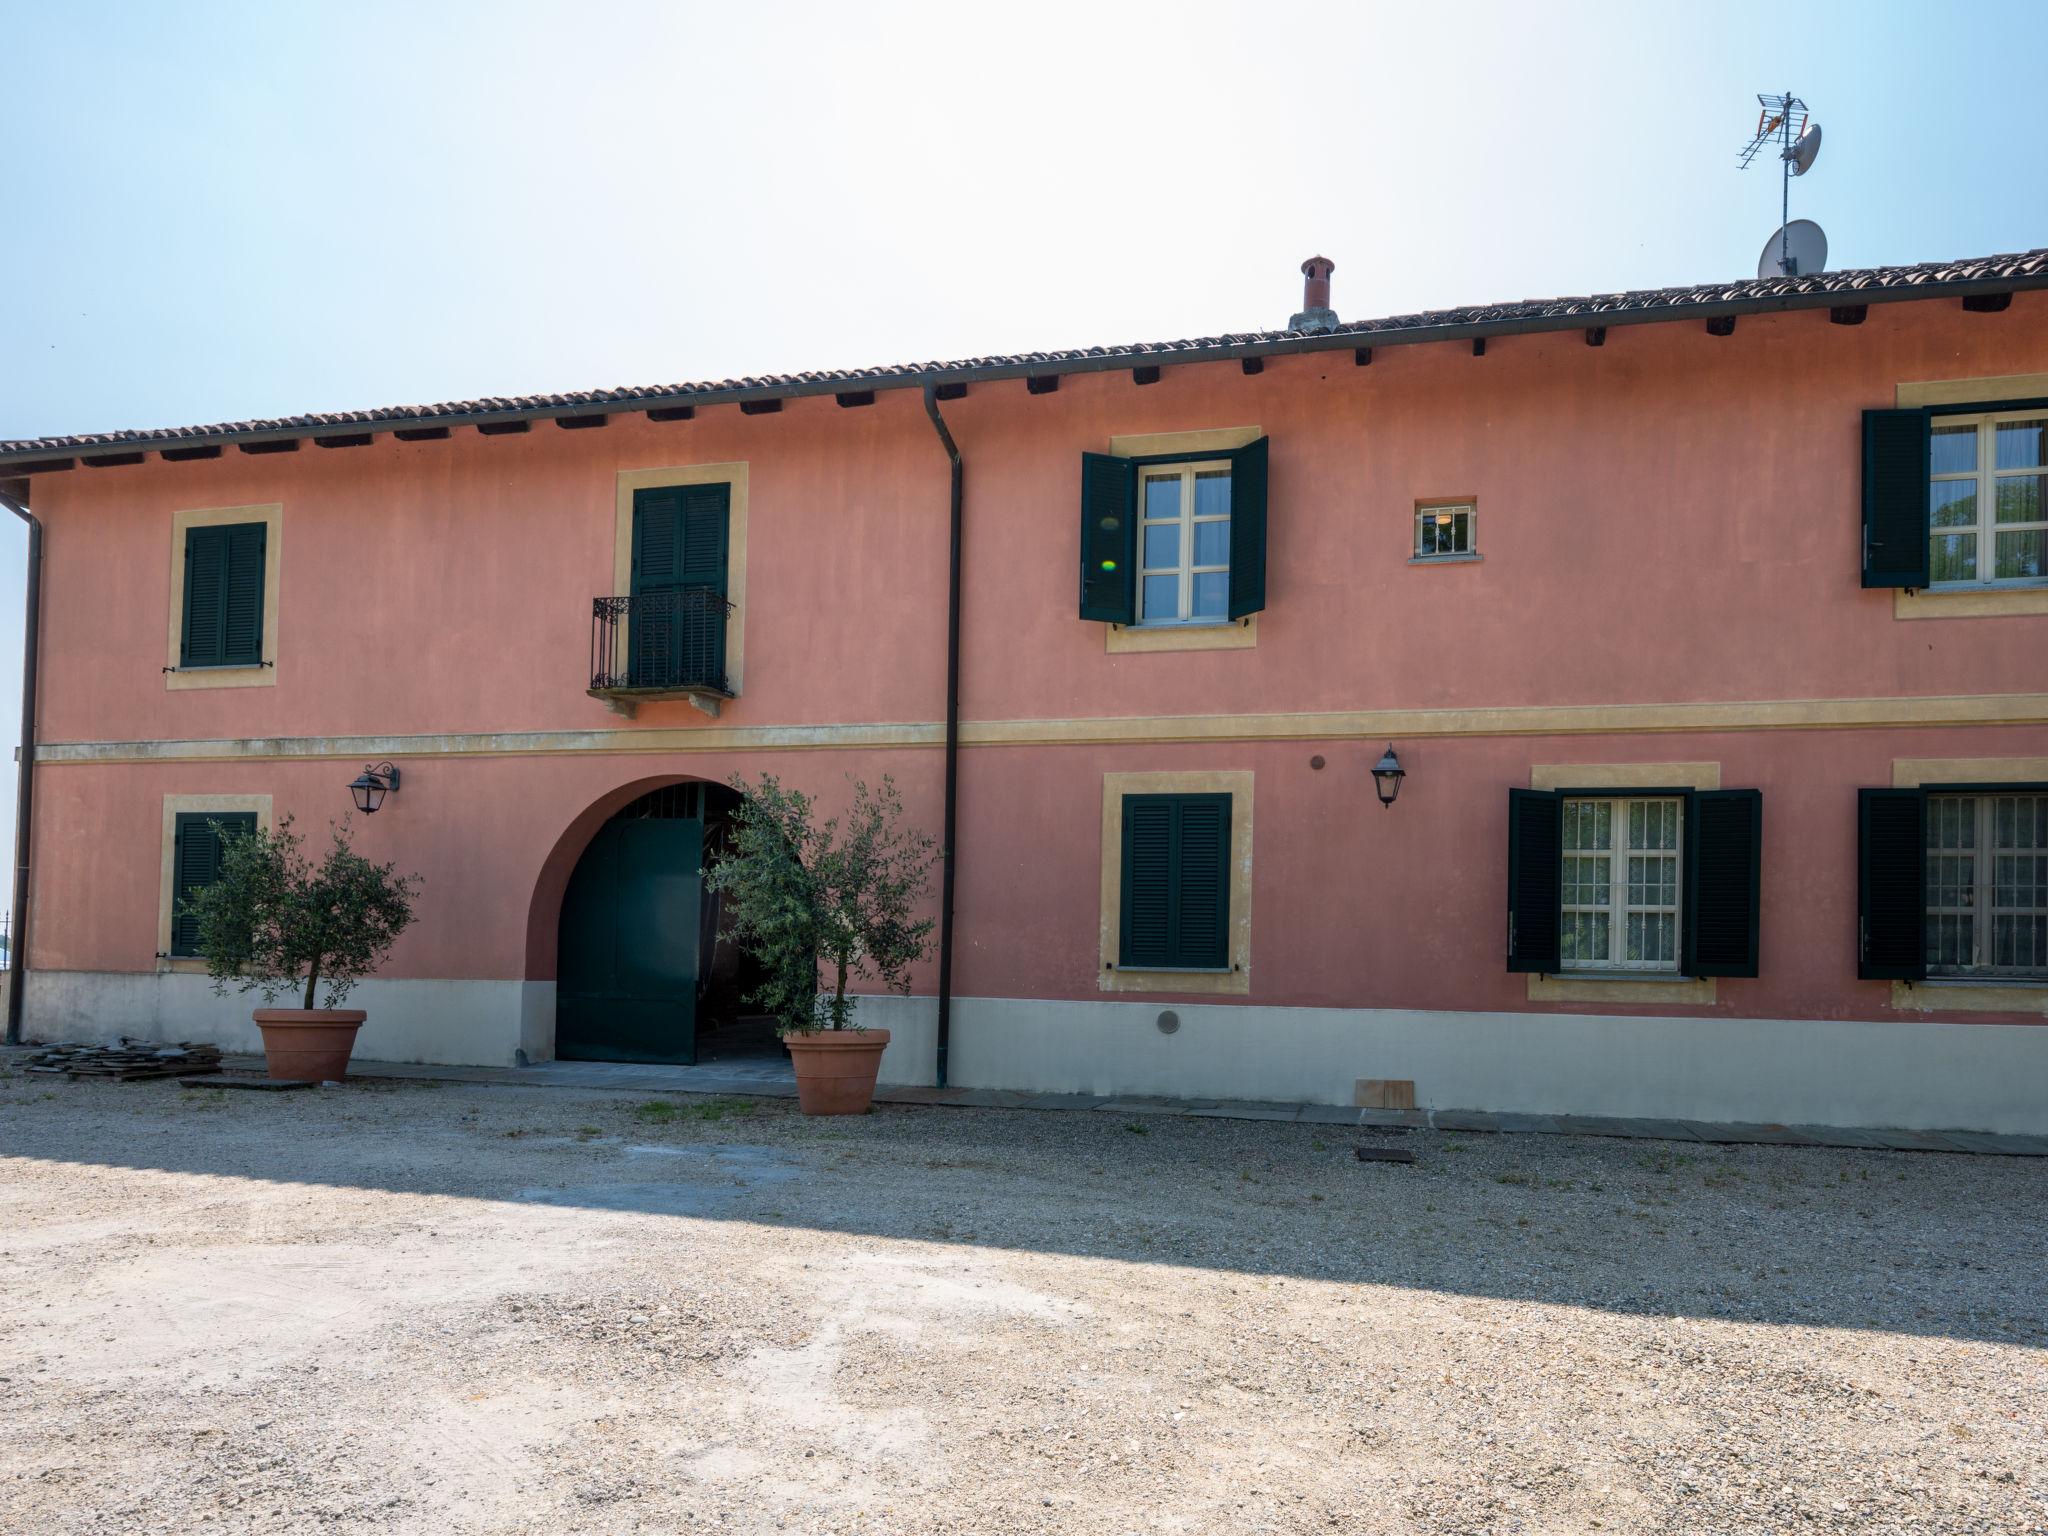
left=0, top=248, right=2048, bottom=465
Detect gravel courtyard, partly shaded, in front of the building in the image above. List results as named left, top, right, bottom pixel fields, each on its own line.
left=0, top=1075, right=2048, bottom=1536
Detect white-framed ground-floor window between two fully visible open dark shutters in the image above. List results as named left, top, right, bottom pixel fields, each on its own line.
left=1561, top=795, right=1686, bottom=973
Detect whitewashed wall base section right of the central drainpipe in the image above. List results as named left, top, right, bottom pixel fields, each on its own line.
left=937, top=997, right=2048, bottom=1135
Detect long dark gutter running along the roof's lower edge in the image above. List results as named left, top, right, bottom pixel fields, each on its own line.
left=0, top=272, right=2048, bottom=473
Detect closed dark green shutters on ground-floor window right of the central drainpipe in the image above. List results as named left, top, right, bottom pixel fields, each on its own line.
left=1118, top=795, right=1231, bottom=971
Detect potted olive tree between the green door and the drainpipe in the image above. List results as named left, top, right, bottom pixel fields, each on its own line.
left=709, top=774, right=938, bottom=1114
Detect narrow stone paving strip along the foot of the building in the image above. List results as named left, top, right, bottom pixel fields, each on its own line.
left=28, top=1047, right=2048, bottom=1157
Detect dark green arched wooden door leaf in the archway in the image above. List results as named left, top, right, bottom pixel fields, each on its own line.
left=555, top=817, right=705, bottom=1063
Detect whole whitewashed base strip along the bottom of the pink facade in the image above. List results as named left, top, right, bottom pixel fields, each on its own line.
left=25, top=971, right=2048, bottom=1135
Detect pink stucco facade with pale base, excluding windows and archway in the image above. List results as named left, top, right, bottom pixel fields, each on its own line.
left=12, top=280, right=2048, bottom=1130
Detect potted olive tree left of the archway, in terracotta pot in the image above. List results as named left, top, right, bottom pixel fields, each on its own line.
left=182, top=817, right=420, bottom=1081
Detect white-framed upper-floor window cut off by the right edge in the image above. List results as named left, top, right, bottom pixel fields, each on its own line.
left=1927, top=410, right=2048, bottom=588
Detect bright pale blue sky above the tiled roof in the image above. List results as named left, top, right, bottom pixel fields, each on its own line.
left=0, top=0, right=2048, bottom=901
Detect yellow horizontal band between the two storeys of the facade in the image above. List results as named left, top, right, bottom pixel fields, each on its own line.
left=35, top=694, right=2048, bottom=764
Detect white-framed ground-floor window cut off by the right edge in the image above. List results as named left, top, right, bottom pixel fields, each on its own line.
left=1927, top=795, right=2048, bottom=977
